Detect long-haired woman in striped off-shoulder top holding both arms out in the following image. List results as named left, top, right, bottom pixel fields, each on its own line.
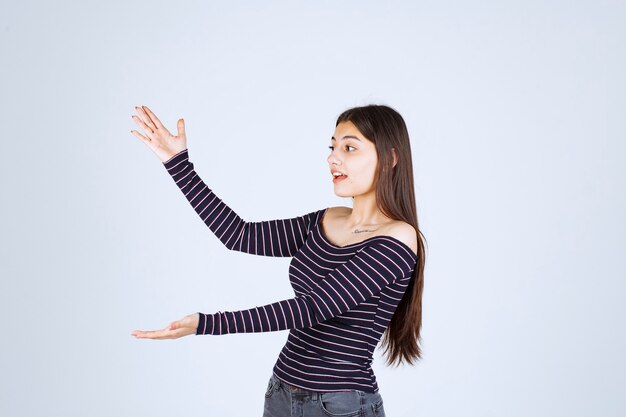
left=131, top=105, right=424, bottom=417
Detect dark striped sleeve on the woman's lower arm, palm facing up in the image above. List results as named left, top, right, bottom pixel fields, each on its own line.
left=196, top=240, right=416, bottom=335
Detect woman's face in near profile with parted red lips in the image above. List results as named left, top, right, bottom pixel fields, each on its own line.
left=327, top=121, right=378, bottom=197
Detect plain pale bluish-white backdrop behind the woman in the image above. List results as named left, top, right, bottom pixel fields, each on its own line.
left=0, top=0, right=626, bottom=417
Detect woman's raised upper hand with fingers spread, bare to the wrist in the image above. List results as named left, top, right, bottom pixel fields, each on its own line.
left=130, top=106, right=187, bottom=162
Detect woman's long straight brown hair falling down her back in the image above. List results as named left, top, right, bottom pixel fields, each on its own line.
left=335, top=104, right=426, bottom=365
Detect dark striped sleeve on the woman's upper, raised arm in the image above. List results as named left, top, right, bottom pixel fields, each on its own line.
left=163, top=149, right=319, bottom=257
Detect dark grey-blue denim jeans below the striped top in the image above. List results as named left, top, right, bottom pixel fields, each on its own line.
left=263, top=374, right=385, bottom=417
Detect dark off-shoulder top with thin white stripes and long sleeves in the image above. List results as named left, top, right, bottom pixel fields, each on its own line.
left=163, top=149, right=417, bottom=392
